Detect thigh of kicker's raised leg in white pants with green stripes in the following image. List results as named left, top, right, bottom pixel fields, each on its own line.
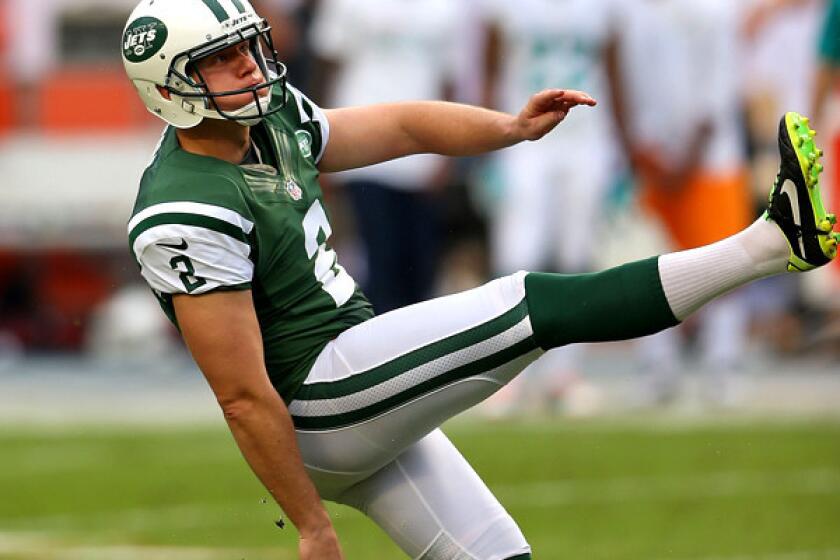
left=296, top=268, right=541, bottom=476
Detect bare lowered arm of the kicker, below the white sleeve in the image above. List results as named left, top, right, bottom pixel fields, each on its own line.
left=173, top=291, right=343, bottom=560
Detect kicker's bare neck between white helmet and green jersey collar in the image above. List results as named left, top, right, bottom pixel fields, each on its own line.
left=176, top=119, right=251, bottom=164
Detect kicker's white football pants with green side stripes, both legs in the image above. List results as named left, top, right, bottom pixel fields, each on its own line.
left=289, top=273, right=541, bottom=560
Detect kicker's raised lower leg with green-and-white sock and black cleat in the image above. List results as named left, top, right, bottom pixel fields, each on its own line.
left=525, top=113, right=840, bottom=349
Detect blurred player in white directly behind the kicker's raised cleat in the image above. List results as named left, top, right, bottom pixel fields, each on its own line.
left=742, top=0, right=834, bottom=354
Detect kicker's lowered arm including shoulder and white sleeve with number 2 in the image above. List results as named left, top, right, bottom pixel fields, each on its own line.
left=128, top=183, right=342, bottom=560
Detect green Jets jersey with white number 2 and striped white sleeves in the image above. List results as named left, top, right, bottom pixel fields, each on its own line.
left=128, top=86, right=373, bottom=402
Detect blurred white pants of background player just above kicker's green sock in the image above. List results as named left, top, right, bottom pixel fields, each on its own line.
left=490, top=138, right=614, bottom=390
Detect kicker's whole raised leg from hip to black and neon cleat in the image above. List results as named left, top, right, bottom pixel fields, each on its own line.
left=289, top=114, right=837, bottom=476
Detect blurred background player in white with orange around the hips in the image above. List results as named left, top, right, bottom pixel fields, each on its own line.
left=617, top=0, right=754, bottom=403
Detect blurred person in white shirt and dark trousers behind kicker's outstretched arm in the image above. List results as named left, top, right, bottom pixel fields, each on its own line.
left=310, top=0, right=464, bottom=313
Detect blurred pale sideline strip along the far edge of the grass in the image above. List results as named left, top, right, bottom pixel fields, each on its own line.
left=0, top=360, right=840, bottom=426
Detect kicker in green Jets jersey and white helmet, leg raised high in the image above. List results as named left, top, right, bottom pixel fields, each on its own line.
left=123, top=0, right=840, bottom=560
